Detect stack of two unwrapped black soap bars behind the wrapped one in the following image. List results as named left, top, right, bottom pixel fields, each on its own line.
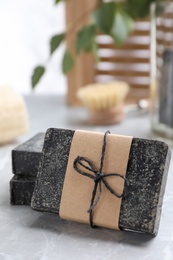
left=10, top=133, right=45, bottom=205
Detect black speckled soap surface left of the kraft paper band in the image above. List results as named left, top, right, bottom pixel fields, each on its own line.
left=32, top=129, right=74, bottom=213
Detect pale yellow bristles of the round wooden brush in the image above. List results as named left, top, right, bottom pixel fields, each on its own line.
left=77, top=81, right=129, bottom=110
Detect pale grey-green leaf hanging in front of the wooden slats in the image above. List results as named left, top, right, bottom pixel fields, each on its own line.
left=112, top=11, right=134, bottom=45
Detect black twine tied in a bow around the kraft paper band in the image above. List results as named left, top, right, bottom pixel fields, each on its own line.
left=73, top=131, right=126, bottom=228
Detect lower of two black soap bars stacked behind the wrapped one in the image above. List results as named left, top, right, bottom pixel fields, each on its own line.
left=10, top=175, right=35, bottom=205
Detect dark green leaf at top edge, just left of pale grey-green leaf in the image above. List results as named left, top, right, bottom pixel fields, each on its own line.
left=93, top=2, right=116, bottom=34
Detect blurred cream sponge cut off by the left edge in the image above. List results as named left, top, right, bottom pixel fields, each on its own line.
left=0, top=87, right=28, bottom=144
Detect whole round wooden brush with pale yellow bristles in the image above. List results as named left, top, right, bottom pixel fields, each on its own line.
left=77, top=81, right=129, bottom=125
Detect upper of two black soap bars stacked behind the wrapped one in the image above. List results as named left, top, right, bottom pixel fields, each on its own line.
left=12, top=133, right=45, bottom=176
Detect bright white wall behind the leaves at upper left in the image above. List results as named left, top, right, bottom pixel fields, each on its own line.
left=0, top=0, right=66, bottom=94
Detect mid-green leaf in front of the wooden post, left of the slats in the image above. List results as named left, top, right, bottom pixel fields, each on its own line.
left=76, top=24, right=96, bottom=53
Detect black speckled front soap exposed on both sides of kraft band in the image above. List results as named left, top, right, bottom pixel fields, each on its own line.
left=31, top=129, right=171, bottom=235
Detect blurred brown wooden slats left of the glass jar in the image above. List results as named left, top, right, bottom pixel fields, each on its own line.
left=96, top=20, right=150, bottom=100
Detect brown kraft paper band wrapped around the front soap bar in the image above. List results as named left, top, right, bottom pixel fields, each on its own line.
left=60, top=130, right=132, bottom=229
